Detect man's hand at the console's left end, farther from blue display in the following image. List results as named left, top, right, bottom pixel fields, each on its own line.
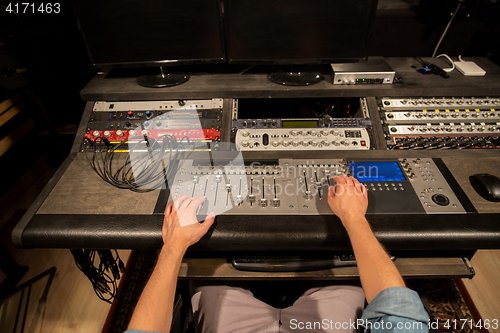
left=162, top=195, right=215, bottom=253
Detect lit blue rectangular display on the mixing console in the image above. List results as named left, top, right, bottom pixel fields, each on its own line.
left=349, top=162, right=406, bottom=182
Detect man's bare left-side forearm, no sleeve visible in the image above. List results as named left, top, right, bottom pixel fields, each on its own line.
left=128, top=247, right=185, bottom=333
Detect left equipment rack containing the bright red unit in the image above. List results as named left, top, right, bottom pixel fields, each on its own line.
left=84, top=99, right=222, bottom=150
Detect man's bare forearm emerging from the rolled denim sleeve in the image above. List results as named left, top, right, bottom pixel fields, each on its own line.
left=346, top=217, right=405, bottom=303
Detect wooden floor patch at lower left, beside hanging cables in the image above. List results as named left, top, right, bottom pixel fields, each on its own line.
left=0, top=249, right=130, bottom=333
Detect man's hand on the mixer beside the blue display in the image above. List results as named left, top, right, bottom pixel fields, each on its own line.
left=328, top=175, right=368, bottom=228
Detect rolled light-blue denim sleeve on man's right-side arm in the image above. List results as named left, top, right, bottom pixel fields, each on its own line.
left=361, top=287, right=429, bottom=333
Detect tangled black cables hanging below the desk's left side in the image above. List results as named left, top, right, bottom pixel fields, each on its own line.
left=71, top=249, right=125, bottom=303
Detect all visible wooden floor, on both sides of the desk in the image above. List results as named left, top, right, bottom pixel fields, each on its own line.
left=0, top=156, right=500, bottom=333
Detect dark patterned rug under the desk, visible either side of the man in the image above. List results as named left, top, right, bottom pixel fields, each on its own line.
left=102, top=251, right=488, bottom=333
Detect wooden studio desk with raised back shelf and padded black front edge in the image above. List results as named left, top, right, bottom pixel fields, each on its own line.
left=13, top=58, right=500, bottom=251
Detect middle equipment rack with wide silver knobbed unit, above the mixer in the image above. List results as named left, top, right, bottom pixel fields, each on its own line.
left=232, top=98, right=371, bottom=151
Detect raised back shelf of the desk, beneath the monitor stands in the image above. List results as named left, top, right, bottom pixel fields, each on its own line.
left=81, top=58, right=500, bottom=101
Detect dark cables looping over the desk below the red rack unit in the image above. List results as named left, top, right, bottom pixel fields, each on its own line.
left=84, top=135, right=190, bottom=193
